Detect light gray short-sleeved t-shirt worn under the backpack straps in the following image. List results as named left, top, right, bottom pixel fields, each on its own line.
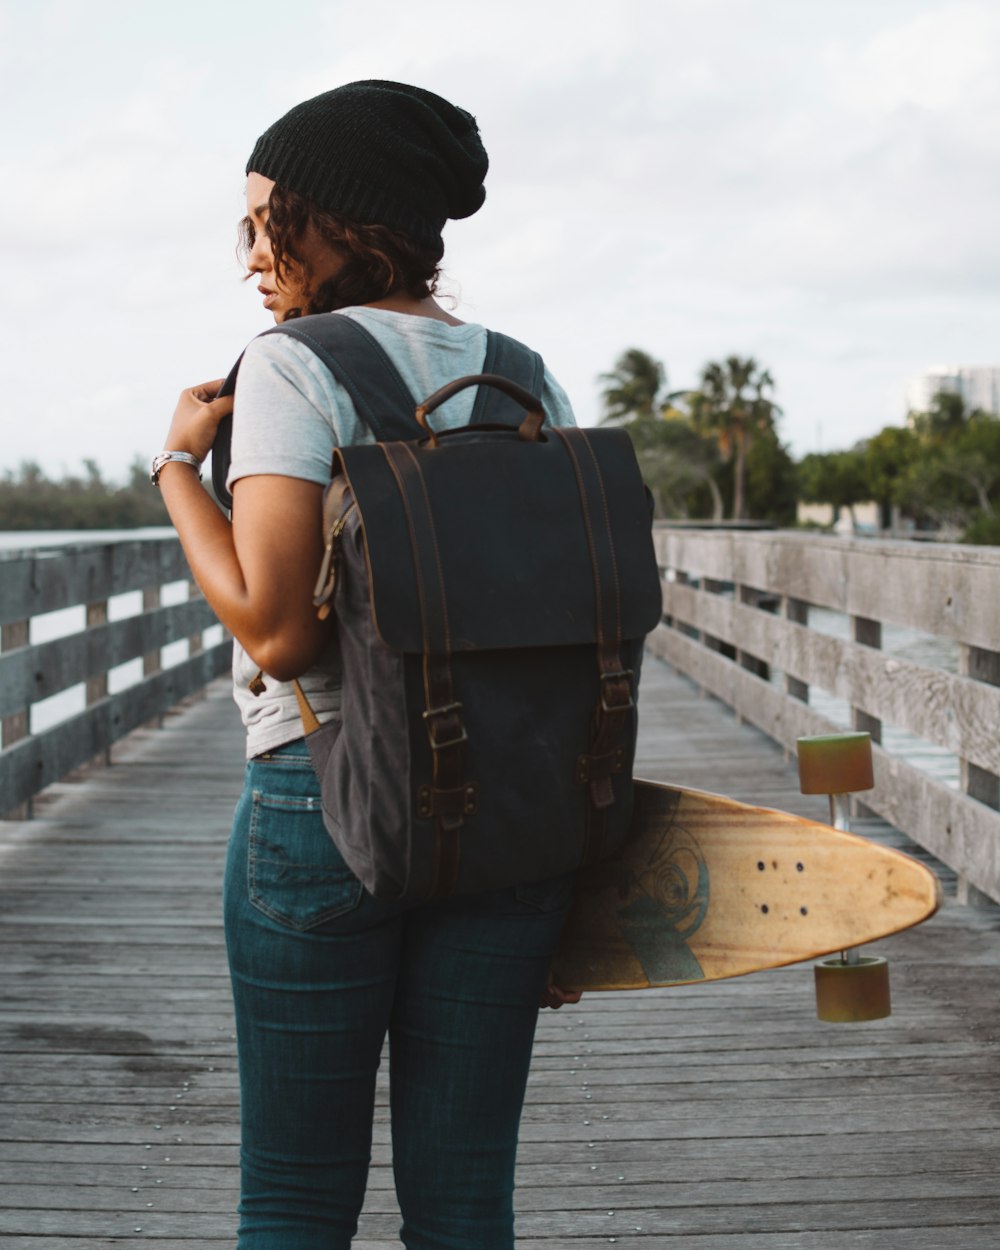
left=222, top=308, right=575, bottom=756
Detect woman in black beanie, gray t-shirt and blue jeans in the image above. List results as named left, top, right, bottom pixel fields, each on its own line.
left=155, top=81, right=575, bottom=1250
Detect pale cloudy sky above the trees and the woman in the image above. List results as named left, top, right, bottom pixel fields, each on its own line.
left=0, top=0, right=1000, bottom=478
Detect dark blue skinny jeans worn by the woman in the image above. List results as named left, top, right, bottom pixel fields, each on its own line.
left=225, top=741, right=573, bottom=1250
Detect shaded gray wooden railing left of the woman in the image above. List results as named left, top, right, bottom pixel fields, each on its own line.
left=0, top=538, right=231, bottom=816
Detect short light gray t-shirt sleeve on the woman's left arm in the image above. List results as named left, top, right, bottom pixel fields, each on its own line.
left=226, top=334, right=370, bottom=486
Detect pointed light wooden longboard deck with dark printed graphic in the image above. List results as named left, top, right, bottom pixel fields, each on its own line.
left=553, top=781, right=940, bottom=990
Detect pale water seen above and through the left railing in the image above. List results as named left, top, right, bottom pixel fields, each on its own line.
left=0, top=526, right=223, bottom=734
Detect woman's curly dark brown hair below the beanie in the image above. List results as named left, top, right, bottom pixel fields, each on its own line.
left=239, top=186, right=444, bottom=316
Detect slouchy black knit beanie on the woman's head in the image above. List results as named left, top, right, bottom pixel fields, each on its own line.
left=246, top=79, right=489, bottom=248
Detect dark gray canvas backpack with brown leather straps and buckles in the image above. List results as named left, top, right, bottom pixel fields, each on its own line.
left=212, top=314, right=661, bottom=901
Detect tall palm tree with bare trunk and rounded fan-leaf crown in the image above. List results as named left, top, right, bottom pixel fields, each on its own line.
left=686, top=356, right=781, bottom=521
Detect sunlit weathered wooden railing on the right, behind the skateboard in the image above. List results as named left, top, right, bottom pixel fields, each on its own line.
left=649, top=528, right=1000, bottom=901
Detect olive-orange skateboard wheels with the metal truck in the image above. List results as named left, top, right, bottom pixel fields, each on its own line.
left=798, top=734, right=893, bottom=1024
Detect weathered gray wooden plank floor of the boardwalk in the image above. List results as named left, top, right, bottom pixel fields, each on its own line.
left=0, top=660, right=1000, bottom=1250
